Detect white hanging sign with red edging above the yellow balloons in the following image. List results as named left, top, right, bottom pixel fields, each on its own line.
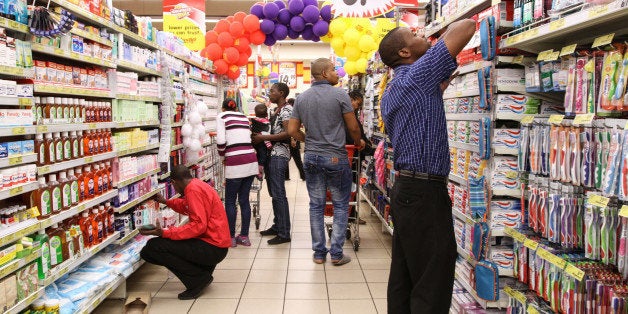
left=331, top=0, right=395, bottom=17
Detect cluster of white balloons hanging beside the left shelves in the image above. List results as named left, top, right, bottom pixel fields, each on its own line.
left=181, top=101, right=211, bottom=157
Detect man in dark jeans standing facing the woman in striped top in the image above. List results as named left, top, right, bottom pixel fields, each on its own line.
left=253, top=83, right=292, bottom=245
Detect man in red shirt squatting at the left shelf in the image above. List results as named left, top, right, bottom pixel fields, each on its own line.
left=140, top=165, right=231, bottom=300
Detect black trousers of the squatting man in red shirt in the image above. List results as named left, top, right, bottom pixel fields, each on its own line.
left=140, top=237, right=228, bottom=289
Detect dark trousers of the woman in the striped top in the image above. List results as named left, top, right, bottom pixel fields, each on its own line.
left=225, top=176, right=255, bottom=238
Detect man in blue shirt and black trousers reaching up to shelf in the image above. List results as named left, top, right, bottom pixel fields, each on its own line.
left=379, top=20, right=475, bottom=314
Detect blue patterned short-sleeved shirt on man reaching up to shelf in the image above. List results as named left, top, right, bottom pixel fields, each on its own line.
left=381, top=40, right=457, bottom=176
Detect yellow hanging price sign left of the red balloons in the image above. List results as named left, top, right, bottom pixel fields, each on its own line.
left=163, top=0, right=205, bottom=51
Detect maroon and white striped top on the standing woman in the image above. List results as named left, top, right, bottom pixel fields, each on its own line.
left=216, top=111, right=259, bottom=179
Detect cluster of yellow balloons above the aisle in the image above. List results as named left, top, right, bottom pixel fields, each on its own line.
left=322, top=17, right=379, bottom=75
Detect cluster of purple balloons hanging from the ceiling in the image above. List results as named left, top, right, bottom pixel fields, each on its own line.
left=251, top=0, right=331, bottom=46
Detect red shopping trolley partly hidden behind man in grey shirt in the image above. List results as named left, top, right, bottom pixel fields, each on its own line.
left=325, top=145, right=360, bottom=251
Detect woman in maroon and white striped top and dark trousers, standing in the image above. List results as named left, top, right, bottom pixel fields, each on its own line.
left=216, top=98, right=259, bottom=247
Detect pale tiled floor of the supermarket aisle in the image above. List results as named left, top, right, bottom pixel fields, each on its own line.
left=96, top=162, right=391, bottom=314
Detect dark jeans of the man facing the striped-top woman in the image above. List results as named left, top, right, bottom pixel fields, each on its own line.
left=264, top=156, right=290, bottom=239
